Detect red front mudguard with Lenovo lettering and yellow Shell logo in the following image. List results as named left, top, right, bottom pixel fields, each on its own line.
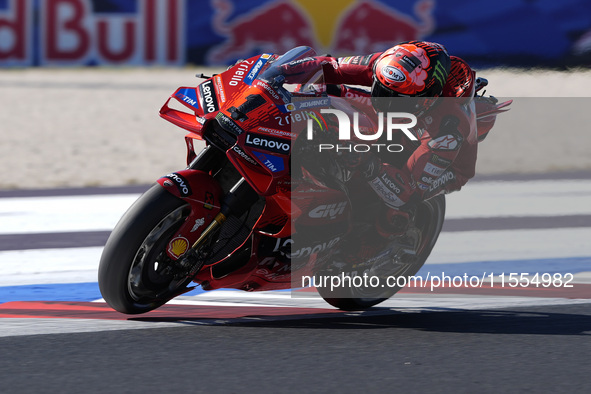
left=156, top=170, right=224, bottom=260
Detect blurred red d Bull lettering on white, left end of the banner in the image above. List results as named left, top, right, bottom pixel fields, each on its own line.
left=0, top=0, right=185, bottom=66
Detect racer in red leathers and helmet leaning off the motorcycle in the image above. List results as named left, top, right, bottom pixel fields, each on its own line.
left=286, top=41, right=494, bottom=236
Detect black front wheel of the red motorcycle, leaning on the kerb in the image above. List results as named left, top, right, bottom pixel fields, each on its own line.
left=98, top=184, right=191, bottom=314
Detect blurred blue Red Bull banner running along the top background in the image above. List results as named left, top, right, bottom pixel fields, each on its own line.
left=0, top=0, right=591, bottom=67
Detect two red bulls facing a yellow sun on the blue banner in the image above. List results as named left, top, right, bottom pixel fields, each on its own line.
left=207, top=0, right=435, bottom=64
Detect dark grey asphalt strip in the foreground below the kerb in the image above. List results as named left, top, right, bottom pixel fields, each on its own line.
left=0, top=304, right=591, bottom=393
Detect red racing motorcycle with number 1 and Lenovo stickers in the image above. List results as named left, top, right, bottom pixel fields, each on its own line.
left=98, top=47, right=507, bottom=314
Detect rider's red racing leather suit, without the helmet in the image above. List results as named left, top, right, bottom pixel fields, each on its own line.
left=288, top=53, right=478, bottom=209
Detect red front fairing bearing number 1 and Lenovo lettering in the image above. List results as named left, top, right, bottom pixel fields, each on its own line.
left=216, top=47, right=323, bottom=196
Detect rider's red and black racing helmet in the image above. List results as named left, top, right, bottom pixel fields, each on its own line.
left=371, top=41, right=451, bottom=115
